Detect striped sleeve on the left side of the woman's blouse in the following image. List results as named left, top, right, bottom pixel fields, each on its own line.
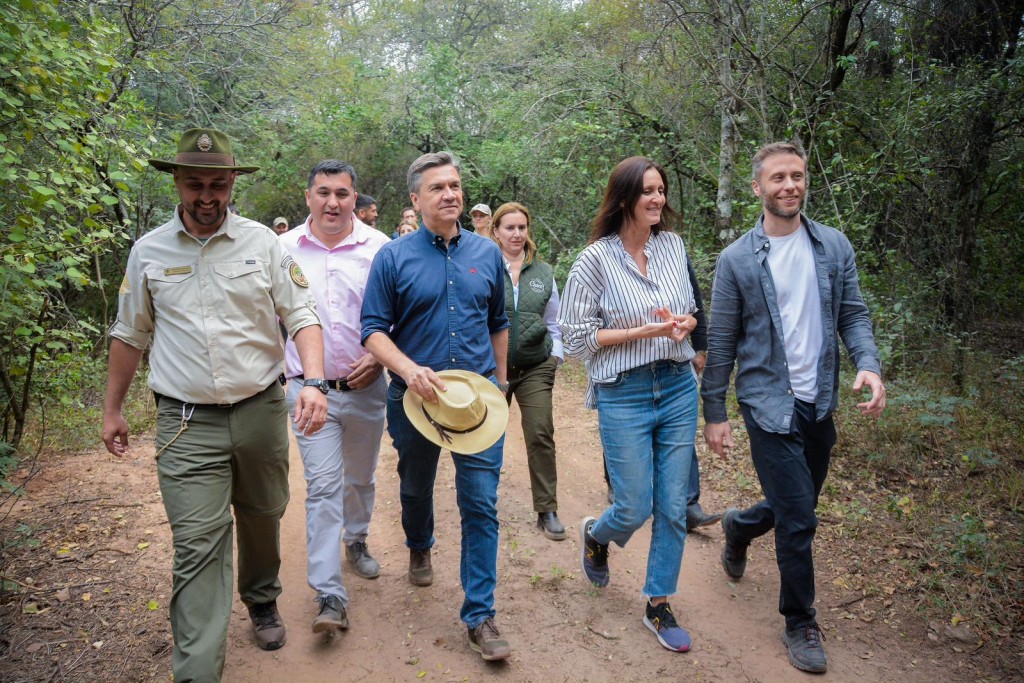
left=558, top=250, right=604, bottom=360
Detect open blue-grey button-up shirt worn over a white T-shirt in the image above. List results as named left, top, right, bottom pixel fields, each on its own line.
left=700, top=216, right=882, bottom=433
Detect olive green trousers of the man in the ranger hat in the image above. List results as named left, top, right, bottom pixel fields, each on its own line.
left=157, top=383, right=289, bottom=683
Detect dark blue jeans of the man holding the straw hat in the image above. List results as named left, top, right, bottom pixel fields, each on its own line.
left=387, top=378, right=505, bottom=629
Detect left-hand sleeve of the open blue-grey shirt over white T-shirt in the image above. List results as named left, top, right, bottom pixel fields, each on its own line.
left=700, top=252, right=742, bottom=423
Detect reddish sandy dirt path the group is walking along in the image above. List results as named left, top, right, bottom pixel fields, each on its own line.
left=211, top=380, right=951, bottom=683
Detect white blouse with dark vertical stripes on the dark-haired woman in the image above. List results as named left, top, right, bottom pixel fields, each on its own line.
left=558, top=230, right=695, bottom=408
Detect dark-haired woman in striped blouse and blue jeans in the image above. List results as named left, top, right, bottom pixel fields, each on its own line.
left=558, top=157, right=697, bottom=652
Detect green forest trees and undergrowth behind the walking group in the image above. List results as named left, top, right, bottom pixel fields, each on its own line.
left=0, top=0, right=1024, bottom=671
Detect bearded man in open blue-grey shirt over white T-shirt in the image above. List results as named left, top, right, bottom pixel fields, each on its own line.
left=700, top=142, right=886, bottom=673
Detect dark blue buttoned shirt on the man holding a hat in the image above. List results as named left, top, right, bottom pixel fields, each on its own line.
left=360, top=227, right=509, bottom=384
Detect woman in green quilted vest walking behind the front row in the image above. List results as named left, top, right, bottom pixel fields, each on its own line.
left=490, top=202, right=565, bottom=541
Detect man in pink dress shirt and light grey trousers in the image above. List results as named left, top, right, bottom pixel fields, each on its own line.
left=281, top=160, right=389, bottom=633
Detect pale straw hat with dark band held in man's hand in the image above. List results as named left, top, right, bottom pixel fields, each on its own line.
left=402, top=370, right=509, bottom=455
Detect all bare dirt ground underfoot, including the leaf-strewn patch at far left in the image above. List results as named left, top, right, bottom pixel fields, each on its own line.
left=0, top=368, right=966, bottom=683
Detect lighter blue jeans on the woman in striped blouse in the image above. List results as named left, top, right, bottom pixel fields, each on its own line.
left=591, top=360, right=697, bottom=597
